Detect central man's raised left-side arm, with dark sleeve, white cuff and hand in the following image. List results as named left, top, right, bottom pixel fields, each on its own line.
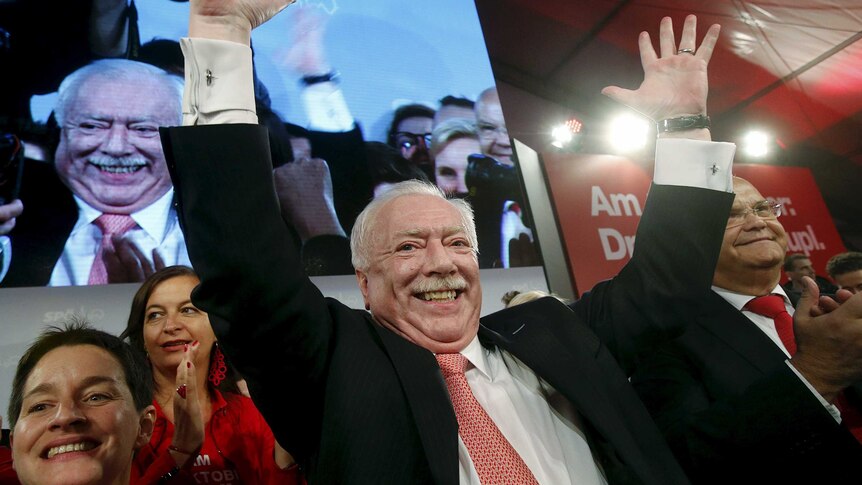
left=162, top=0, right=332, bottom=462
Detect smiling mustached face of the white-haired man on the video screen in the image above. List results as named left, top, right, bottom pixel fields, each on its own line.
left=55, top=76, right=179, bottom=214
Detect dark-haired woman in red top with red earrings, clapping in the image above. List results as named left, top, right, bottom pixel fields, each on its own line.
left=121, top=266, right=303, bottom=484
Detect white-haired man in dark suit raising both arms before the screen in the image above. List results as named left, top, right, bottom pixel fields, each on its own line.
left=163, top=0, right=744, bottom=484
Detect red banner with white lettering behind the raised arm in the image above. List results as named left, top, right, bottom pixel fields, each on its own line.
left=542, top=153, right=845, bottom=294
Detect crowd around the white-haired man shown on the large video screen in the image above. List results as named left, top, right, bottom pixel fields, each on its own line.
left=0, top=0, right=539, bottom=287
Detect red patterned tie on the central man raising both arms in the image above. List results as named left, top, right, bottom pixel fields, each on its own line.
left=437, top=354, right=539, bottom=485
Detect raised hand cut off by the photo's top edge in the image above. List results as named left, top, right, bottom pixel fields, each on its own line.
left=189, top=0, right=296, bottom=45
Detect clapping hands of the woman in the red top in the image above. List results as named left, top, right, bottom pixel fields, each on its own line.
left=168, top=341, right=204, bottom=467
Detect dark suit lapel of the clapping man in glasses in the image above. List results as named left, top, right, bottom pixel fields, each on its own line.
left=697, top=292, right=787, bottom=374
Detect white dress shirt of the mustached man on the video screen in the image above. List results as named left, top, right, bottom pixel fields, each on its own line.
left=48, top=189, right=191, bottom=286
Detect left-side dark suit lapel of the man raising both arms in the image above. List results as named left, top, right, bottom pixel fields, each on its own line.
left=373, top=324, right=458, bottom=484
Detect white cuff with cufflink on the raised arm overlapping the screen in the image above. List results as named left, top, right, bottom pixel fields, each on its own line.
left=180, top=37, right=257, bottom=125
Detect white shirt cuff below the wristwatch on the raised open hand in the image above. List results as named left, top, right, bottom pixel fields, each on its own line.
left=653, top=138, right=736, bottom=192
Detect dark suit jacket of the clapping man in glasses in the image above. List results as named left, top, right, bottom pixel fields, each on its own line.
left=632, top=292, right=862, bottom=483
